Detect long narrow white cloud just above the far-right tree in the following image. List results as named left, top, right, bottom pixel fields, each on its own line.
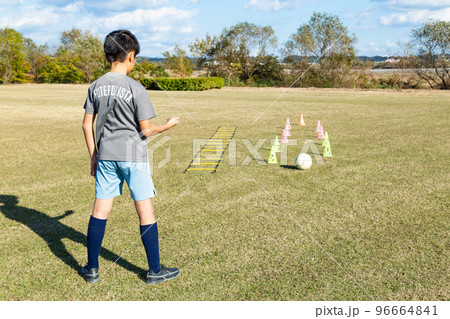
left=380, top=7, right=450, bottom=26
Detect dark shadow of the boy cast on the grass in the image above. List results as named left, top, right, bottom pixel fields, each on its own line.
left=0, top=195, right=145, bottom=277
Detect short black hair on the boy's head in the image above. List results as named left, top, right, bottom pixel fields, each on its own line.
left=103, top=30, right=141, bottom=63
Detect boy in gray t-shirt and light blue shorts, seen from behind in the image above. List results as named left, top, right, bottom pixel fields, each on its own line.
left=80, top=30, right=180, bottom=284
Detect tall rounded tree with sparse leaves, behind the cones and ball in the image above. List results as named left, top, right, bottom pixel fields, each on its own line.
left=285, top=12, right=356, bottom=86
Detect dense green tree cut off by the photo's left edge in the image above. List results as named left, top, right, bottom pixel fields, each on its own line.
left=0, top=28, right=29, bottom=84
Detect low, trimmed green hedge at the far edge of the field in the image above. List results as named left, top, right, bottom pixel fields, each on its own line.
left=141, top=77, right=224, bottom=91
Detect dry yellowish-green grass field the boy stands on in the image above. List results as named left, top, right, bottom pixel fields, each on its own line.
left=0, top=85, right=450, bottom=300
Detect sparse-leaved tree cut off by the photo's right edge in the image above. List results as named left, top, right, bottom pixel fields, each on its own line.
left=411, top=21, right=450, bottom=90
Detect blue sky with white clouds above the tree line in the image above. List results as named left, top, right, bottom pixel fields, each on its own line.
left=0, top=0, right=450, bottom=57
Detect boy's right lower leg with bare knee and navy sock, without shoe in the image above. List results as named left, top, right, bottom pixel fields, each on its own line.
left=134, top=198, right=161, bottom=273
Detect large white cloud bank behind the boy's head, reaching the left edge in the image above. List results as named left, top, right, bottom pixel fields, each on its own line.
left=0, top=0, right=198, bottom=56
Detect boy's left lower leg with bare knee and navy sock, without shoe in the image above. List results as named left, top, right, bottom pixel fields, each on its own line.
left=87, top=198, right=114, bottom=270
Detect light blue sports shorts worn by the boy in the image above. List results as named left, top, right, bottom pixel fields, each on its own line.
left=95, top=160, right=156, bottom=201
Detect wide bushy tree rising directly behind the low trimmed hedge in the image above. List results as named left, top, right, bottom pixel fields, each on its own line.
left=189, top=22, right=278, bottom=82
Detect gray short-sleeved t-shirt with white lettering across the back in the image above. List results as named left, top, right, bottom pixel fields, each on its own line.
left=84, top=72, right=156, bottom=162
